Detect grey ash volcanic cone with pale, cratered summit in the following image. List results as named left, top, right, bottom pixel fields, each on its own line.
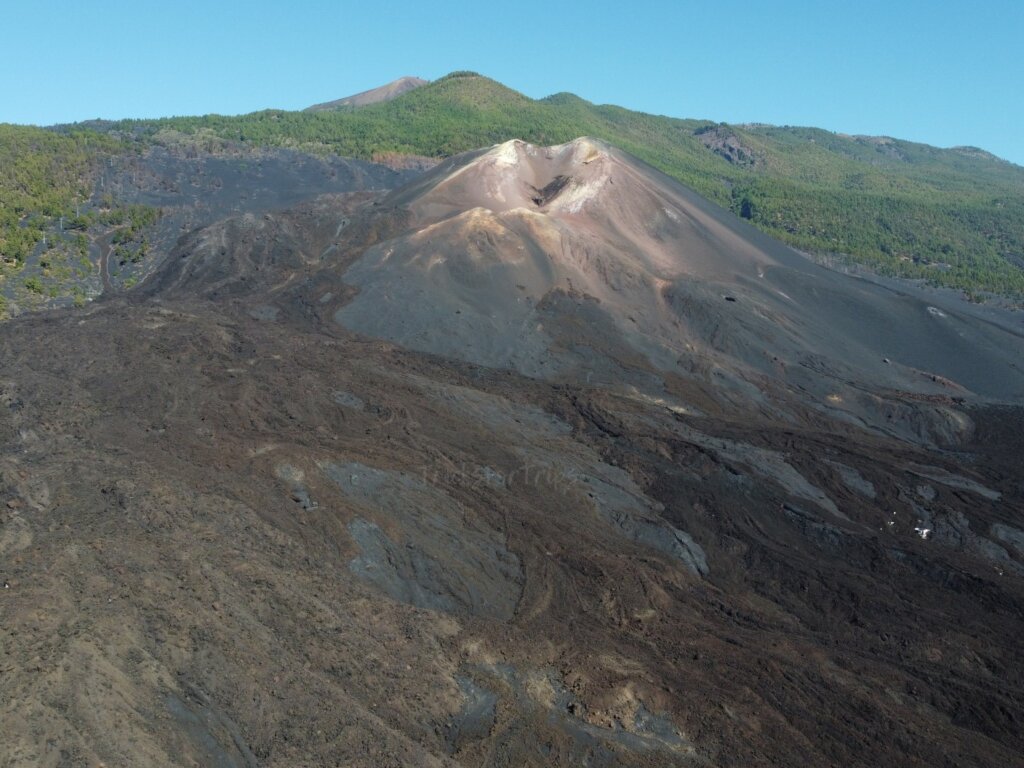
left=335, top=138, right=1024, bottom=440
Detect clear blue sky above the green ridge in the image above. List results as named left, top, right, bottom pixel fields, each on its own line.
left=6, top=0, right=1024, bottom=164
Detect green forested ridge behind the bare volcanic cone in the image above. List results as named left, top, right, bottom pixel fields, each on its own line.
left=0, top=73, right=1024, bottom=297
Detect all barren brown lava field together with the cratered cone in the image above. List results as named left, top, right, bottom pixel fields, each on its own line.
left=0, top=139, right=1024, bottom=766
